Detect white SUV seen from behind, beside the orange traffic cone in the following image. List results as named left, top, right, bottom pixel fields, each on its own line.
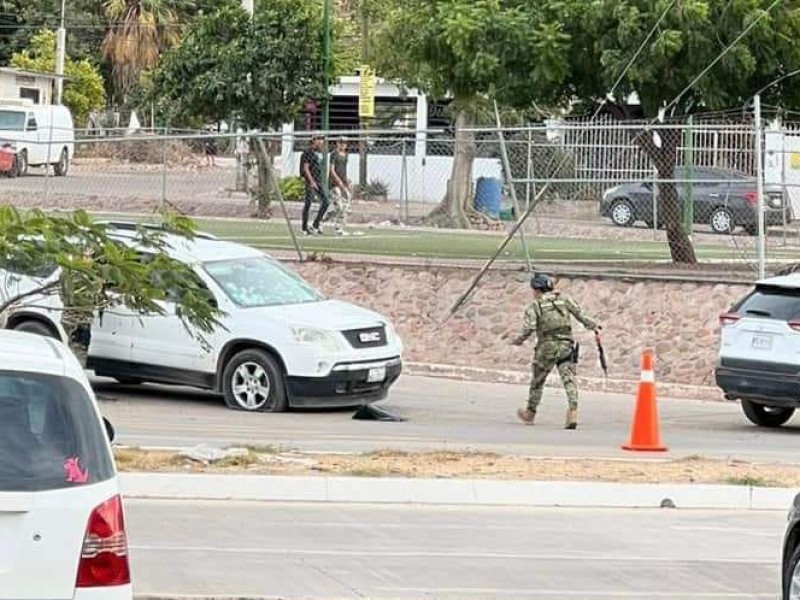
left=716, top=274, right=800, bottom=427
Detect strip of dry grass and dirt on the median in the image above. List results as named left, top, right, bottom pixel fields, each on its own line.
left=115, top=448, right=800, bottom=487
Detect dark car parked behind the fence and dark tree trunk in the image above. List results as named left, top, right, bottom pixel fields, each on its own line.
left=600, top=167, right=794, bottom=235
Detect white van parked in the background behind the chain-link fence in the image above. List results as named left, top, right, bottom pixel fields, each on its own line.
left=0, top=98, right=75, bottom=177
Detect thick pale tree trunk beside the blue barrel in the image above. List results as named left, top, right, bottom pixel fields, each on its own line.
left=429, top=110, right=477, bottom=229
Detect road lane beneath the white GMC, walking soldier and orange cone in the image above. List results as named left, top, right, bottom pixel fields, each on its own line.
left=95, top=376, right=800, bottom=463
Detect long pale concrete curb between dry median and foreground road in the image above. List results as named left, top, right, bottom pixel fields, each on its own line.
left=120, top=473, right=796, bottom=511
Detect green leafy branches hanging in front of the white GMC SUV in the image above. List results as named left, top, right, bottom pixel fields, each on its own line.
left=0, top=205, right=220, bottom=364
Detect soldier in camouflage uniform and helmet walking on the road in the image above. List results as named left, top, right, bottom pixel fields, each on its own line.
left=512, top=274, right=601, bottom=429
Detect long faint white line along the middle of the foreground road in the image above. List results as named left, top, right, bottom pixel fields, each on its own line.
left=130, top=544, right=776, bottom=566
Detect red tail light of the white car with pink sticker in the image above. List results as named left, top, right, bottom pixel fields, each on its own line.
left=75, top=496, right=131, bottom=588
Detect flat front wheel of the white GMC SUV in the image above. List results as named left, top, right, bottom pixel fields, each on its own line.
left=222, top=349, right=289, bottom=412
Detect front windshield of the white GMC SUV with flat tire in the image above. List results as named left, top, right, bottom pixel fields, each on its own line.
left=203, top=256, right=323, bottom=308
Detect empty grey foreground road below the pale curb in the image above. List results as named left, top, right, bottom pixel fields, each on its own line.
left=126, top=501, right=785, bottom=600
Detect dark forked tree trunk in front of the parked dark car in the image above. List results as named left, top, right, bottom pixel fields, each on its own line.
left=637, top=129, right=697, bottom=265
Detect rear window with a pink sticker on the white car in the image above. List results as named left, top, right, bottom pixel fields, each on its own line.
left=0, top=370, right=114, bottom=492
